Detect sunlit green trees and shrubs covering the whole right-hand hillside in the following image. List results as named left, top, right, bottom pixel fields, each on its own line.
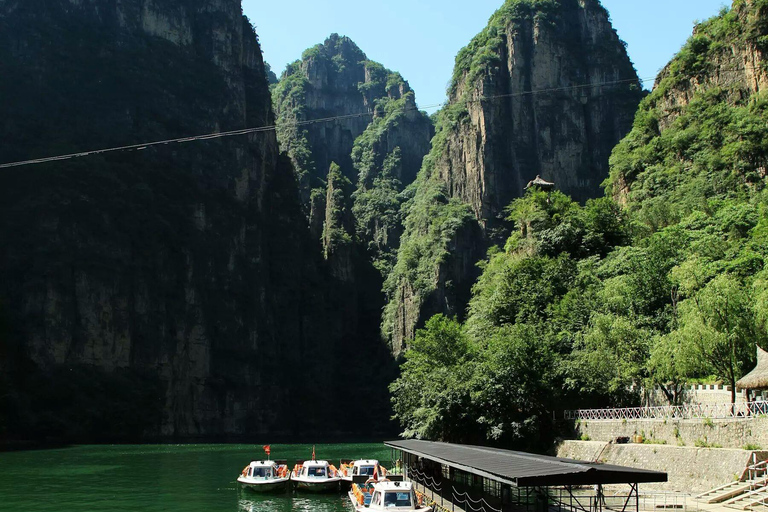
left=390, top=0, right=768, bottom=447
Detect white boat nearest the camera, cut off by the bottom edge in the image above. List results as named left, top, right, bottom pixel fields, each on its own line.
left=348, top=480, right=432, bottom=512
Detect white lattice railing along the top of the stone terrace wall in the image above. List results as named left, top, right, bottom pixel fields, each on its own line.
left=565, top=402, right=768, bottom=421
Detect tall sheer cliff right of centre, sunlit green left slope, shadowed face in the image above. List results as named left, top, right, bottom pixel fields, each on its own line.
left=383, top=0, right=642, bottom=352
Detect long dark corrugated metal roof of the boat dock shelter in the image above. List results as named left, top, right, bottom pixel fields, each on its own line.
left=385, top=439, right=667, bottom=487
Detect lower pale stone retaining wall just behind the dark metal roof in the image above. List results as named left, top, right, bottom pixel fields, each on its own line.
left=557, top=441, right=768, bottom=494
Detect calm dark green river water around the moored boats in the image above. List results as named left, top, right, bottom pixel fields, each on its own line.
left=0, top=444, right=391, bottom=512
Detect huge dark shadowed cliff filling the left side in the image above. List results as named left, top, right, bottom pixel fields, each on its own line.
left=0, top=0, right=386, bottom=441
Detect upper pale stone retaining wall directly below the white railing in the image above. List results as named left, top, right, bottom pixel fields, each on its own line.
left=576, top=417, right=768, bottom=450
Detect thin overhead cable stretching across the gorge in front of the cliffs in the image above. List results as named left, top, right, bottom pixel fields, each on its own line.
left=0, top=74, right=668, bottom=169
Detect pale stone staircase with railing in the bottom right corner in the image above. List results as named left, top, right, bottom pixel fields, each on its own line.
left=694, top=461, right=768, bottom=512
